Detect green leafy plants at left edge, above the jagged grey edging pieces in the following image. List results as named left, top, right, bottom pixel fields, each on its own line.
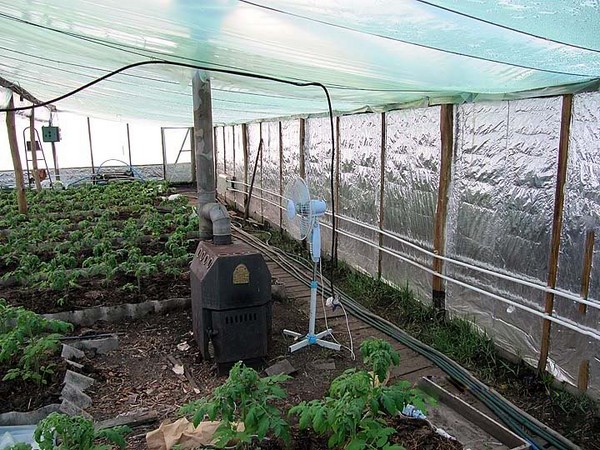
left=0, top=299, right=73, bottom=384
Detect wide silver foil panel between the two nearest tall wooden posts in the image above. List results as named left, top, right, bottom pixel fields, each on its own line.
left=446, top=98, right=561, bottom=376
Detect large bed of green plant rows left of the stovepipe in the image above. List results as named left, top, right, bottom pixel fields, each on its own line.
left=0, top=183, right=198, bottom=312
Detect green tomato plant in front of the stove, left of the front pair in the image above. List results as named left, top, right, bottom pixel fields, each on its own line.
left=181, top=362, right=290, bottom=447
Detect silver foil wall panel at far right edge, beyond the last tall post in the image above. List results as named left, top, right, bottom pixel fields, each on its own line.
left=550, top=93, right=600, bottom=398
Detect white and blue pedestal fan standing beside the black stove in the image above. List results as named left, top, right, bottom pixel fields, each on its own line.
left=283, top=178, right=341, bottom=353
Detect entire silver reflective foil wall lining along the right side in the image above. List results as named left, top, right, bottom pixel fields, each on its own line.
left=217, top=93, right=600, bottom=397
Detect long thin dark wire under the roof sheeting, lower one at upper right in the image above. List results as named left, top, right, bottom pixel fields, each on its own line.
left=238, top=0, right=595, bottom=78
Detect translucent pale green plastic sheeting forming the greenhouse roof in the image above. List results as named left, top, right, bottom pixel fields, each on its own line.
left=0, top=0, right=600, bottom=125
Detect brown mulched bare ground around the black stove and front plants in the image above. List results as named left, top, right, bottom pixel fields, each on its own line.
left=80, top=301, right=462, bottom=450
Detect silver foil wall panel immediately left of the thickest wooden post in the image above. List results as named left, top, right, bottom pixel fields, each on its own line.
left=381, top=106, right=441, bottom=302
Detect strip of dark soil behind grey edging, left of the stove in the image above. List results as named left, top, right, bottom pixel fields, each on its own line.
left=0, top=272, right=190, bottom=314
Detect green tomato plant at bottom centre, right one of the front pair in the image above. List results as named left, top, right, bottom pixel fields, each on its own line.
left=290, top=339, right=428, bottom=450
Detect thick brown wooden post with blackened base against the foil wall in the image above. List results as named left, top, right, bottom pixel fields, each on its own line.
left=432, top=105, right=454, bottom=320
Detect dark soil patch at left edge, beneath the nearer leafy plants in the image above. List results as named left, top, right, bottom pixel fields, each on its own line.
left=0, top=356, right=66, bottom=414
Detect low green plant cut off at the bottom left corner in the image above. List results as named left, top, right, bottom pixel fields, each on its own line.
left=10, top=413, right=131, bottom=450
